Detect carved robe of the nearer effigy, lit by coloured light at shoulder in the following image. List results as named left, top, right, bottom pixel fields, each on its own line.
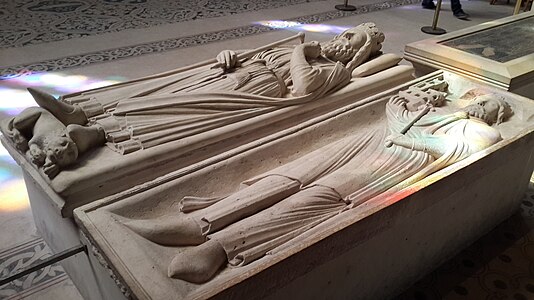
left=184, top=104, right=500, bottom=266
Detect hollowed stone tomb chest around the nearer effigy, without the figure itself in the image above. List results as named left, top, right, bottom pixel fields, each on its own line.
left=75, top=71, right=534, bottom=299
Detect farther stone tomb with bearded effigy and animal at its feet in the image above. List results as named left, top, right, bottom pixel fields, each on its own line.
left=0, top=23, right=413, bottom=299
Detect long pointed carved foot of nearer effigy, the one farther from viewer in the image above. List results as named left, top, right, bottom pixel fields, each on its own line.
left=124, top=215, right=206, bottom=246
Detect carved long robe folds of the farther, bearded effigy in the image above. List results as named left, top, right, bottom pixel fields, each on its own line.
left=63, top=48, right=350, bottom=153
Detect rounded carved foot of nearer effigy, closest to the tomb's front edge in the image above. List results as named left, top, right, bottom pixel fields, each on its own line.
left=168, top=240, right=227, bottom=283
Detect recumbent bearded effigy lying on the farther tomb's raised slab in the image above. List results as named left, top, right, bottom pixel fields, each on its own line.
left=4, top=23, right=390, bottom=178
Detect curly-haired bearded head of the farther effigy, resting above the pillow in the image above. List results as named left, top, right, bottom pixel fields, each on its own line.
left=321, top=23, right=385, bottom=64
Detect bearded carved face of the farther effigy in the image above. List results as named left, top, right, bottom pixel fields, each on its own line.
left=321, top=28, right=367, bottom=64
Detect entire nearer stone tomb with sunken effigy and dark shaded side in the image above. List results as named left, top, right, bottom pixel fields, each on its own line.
left=75, top=71, right=534, bottom=299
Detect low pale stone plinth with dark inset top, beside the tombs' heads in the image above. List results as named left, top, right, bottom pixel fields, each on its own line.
left=404, top=12, right=534, bottom=98
